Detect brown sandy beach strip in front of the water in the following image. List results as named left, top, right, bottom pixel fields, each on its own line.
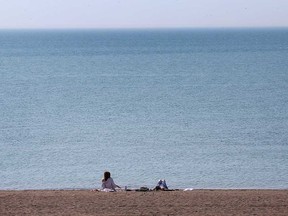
left=0, top=190, right=288, bottom=216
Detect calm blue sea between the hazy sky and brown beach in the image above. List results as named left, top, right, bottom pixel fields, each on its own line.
left=0, top=28, right=288, bottom=189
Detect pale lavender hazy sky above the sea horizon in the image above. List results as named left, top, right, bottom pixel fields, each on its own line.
left=0, top=0, right=288, bottom=28
